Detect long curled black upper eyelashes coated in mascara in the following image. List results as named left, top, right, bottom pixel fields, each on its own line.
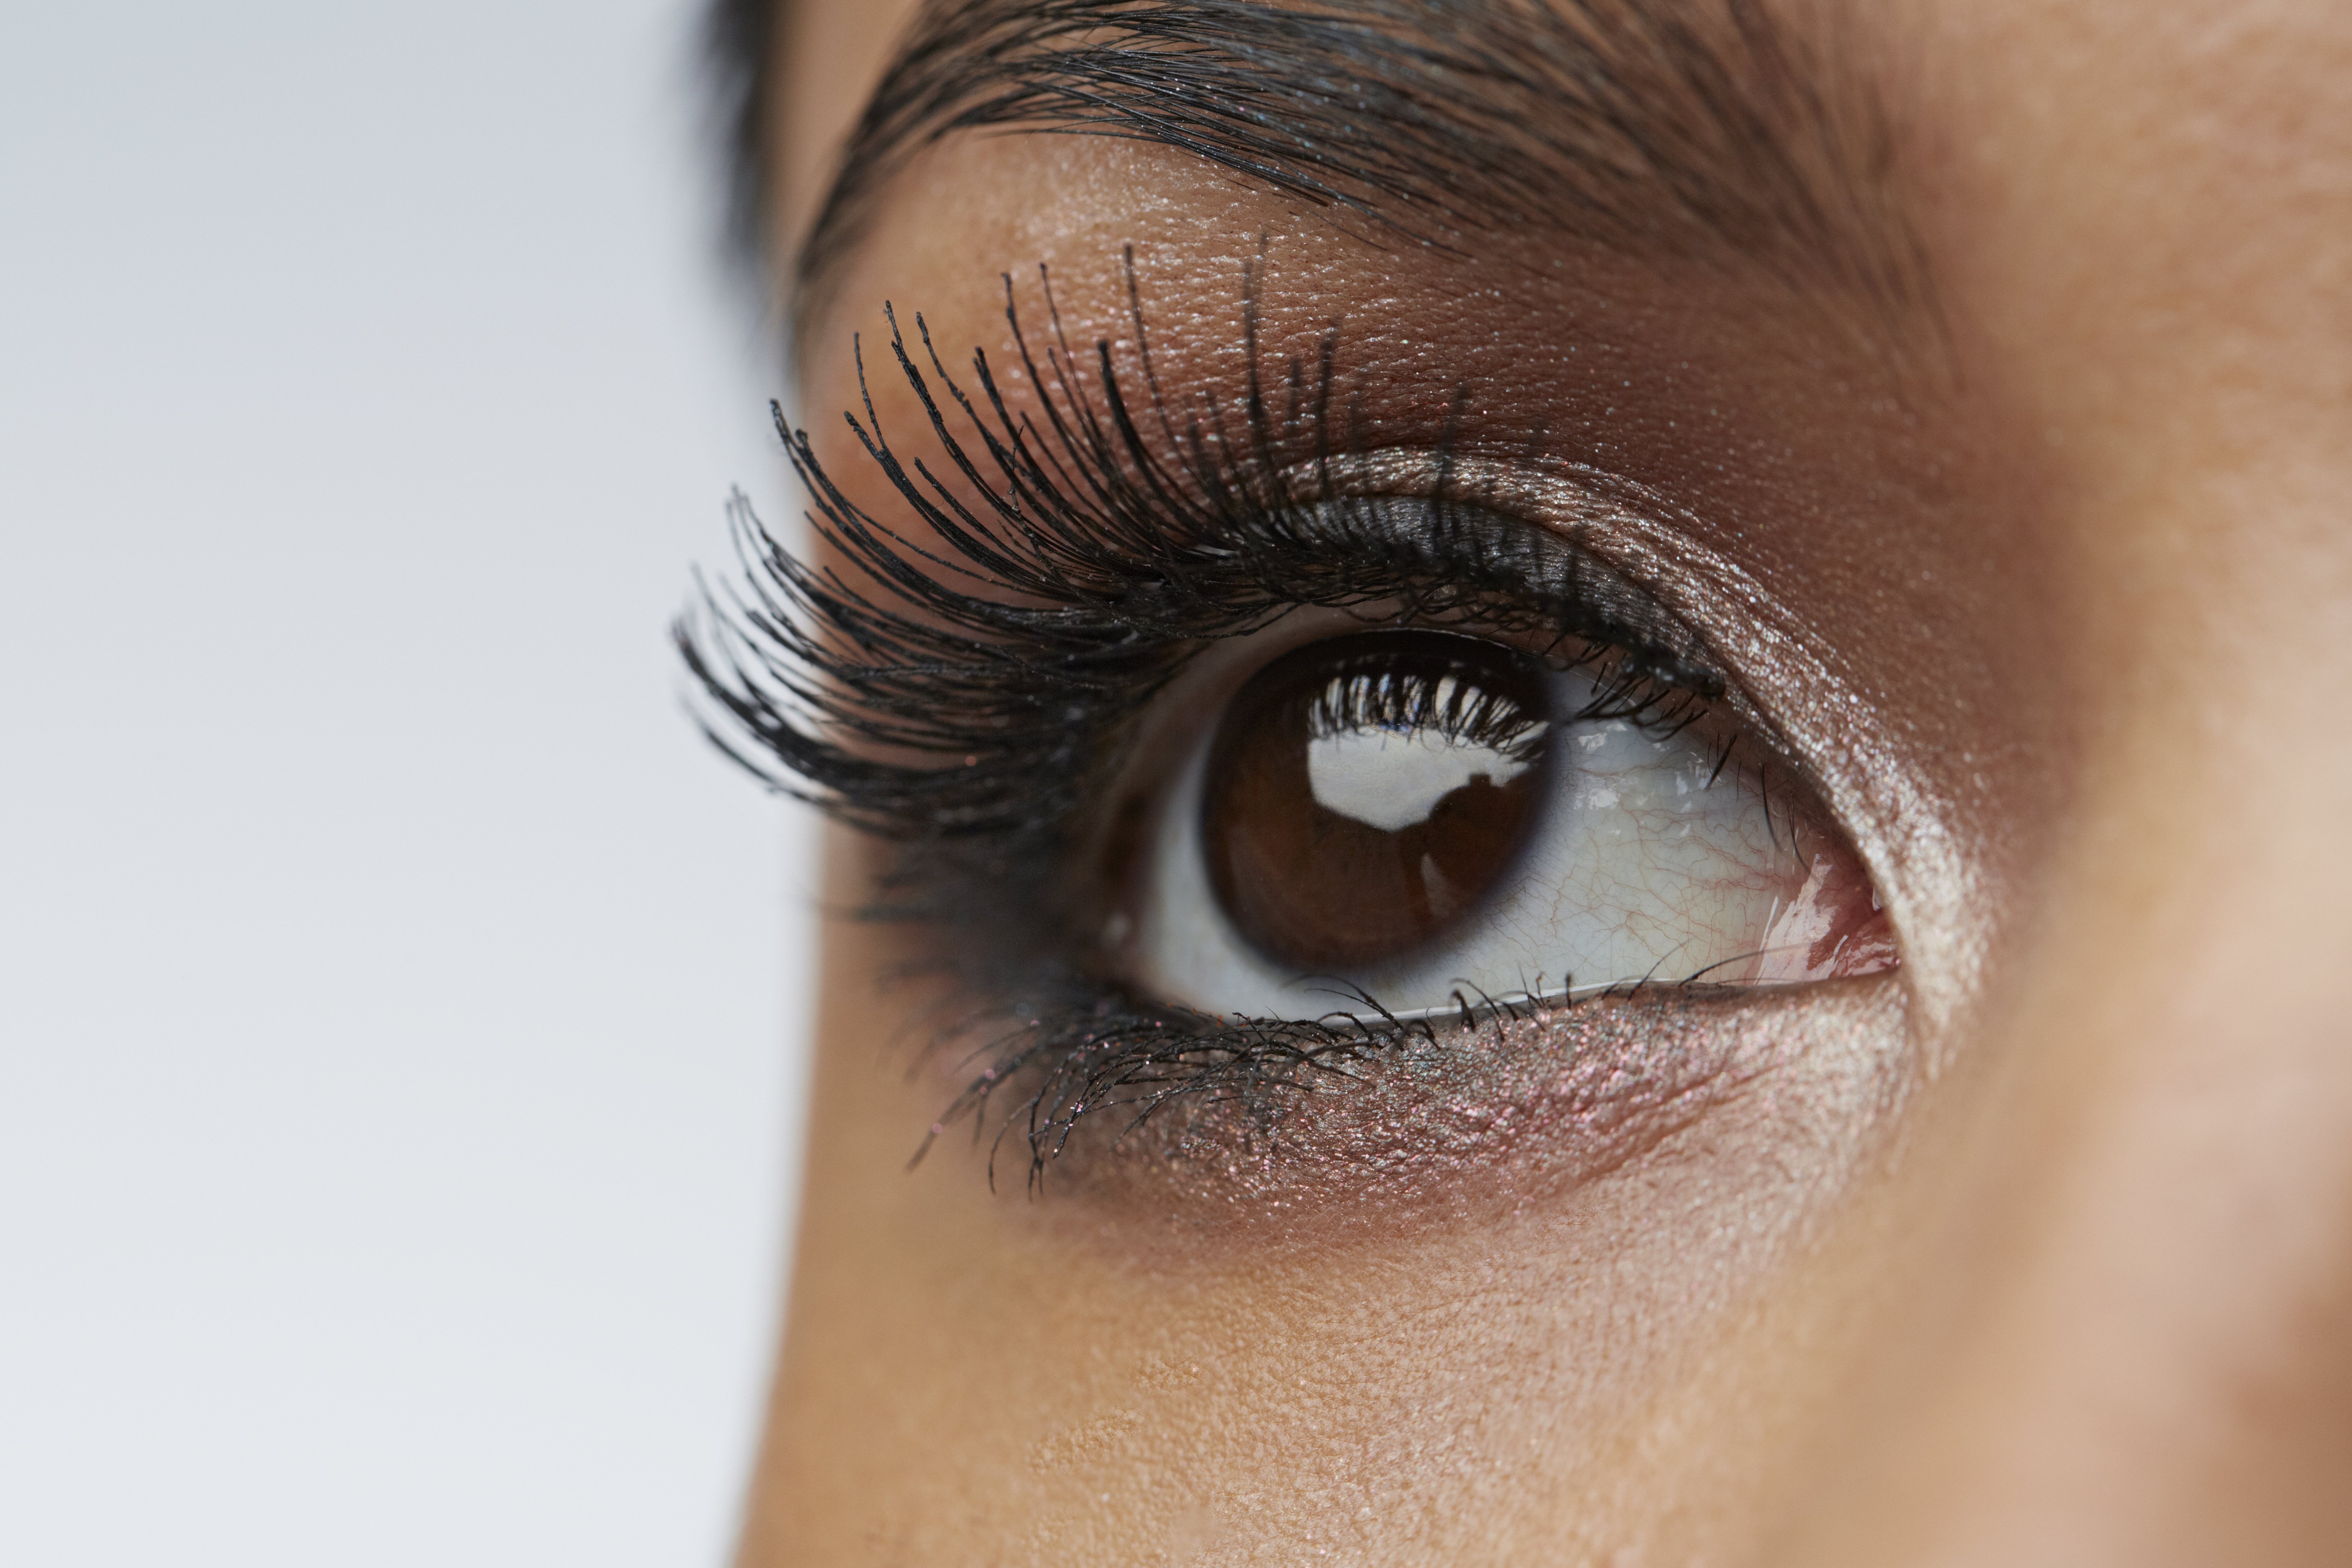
left=675, top=258, right=1722, bottom=839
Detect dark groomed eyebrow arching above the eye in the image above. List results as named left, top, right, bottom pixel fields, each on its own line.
left=795, top=0, right=1924, bottom=329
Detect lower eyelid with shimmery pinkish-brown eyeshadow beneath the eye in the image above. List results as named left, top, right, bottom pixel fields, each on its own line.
left=983, top=980, right=1907, bottom=1246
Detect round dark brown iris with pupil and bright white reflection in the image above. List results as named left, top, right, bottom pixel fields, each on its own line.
left=1202, top=633, right=1550, bottom=971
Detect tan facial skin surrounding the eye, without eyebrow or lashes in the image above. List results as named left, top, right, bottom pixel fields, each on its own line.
left=741, top=0, right=2352, bottom=1568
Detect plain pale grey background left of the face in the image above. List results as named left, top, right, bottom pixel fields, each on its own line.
left=0, top=0, right=811, bottom=1568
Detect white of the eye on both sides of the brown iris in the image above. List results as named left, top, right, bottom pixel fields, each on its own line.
left=1134, top=670, right=1804, bottom=1018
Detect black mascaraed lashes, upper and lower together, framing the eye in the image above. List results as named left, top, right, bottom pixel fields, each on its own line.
left=675, top=256, right=1719, bottom=1180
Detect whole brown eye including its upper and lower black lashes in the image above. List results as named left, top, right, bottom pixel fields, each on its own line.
left=680, top=261, right=1898, bottom=1178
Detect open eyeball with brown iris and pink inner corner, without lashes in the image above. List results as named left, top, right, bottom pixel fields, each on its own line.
left=1124, top=625, right=1896, bottom=1020
